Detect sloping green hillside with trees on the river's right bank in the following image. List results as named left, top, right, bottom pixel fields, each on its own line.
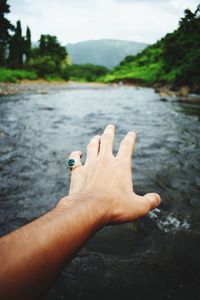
left=104, top=6, right=200, bottom=91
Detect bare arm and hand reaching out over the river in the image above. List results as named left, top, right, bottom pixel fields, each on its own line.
left=0, top=125, right=160, bottom=300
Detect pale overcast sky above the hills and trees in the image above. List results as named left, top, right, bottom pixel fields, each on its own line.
left=7, top=0, right=200, bottom=44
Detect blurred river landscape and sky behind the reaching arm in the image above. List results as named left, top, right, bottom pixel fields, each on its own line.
left=0, top=0, right=200, bottom=300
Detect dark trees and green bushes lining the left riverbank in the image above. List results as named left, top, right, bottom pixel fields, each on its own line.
left=0, top=0, right=108, bottom=81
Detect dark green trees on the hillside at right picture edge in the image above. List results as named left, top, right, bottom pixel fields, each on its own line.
left=163, top=5, right=200, bottom=84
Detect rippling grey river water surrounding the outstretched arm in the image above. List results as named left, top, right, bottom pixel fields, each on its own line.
left=0, top=85, right=200, bottom=300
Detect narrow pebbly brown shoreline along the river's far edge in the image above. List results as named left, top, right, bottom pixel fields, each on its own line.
left=0, top=79, right=200, bottom=105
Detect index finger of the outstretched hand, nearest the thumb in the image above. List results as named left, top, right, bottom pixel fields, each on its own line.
left=117, top=131, right=136, bottom=159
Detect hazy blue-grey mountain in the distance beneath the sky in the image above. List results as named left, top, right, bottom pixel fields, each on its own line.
left=66, top=39, right=148, bottom=68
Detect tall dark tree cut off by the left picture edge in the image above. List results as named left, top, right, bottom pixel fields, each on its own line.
left=0, top=0, right=14, bottom=66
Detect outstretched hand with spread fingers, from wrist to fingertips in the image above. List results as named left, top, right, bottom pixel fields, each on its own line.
left=58, top=125, right=160, bottom=223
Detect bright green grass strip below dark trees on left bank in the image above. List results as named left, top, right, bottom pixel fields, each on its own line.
left=0, top=68, right=38, bottom=82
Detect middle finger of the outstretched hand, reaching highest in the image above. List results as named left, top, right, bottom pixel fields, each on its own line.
left=99, top=124, right=115, bottom=155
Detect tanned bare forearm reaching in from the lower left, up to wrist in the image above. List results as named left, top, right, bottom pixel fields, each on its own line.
left=0, top=196, right=105, bottom=299
